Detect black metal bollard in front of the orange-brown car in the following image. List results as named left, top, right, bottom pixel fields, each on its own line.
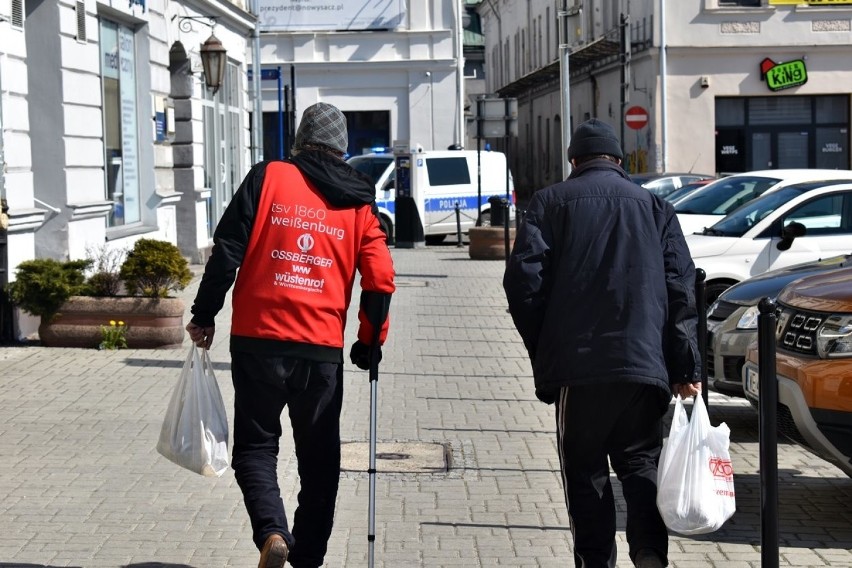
left=757, top=298, right=778, bottom=568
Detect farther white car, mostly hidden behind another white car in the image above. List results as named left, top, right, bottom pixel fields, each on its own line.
left=675, top=169, right=852, bottom=235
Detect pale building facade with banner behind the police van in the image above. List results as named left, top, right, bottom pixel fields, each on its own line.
left=255, top=0, right=466, bottom=158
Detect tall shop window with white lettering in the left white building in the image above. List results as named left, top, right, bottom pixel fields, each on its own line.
left=100, top=20, right=141, bottom=227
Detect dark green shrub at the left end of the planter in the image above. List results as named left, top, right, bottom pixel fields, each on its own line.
left=9, top=258, right=91, bottom=321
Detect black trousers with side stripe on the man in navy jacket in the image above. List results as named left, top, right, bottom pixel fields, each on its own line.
left=556, top=384, right=671, bottom=568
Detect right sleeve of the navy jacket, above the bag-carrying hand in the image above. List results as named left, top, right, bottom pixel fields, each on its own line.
left=662, top=206, right=701, bottom=384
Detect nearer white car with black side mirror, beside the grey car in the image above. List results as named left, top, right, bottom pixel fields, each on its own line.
left=686, top=180, right=852, bottom=304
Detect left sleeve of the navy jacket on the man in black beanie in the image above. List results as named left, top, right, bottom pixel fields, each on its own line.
left=503, top=195, right=552, bottom=361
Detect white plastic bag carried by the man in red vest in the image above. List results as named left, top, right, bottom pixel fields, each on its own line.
left=157, top=345, right=228, bottom=477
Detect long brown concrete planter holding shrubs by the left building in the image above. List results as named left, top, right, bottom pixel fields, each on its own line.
left=38, top=296, right=185, bottom=349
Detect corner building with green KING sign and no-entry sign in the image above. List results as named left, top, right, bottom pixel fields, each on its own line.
left=479, top=0, right=852, bottom=200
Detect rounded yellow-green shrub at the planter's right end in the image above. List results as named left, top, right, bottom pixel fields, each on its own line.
left=120, top=239, right=192, bottom=298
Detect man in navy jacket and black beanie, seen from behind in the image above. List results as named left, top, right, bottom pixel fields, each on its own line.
left=503, top=119, right=701, bottom=568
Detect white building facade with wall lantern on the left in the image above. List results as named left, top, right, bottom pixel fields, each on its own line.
left=0, top=0, right=254, bottom=340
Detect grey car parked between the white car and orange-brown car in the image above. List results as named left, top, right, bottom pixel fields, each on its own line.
left=707, top=254, right=852, bottom=396
